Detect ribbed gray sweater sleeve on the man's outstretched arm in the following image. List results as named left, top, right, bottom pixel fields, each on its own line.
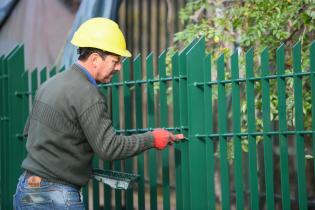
left=79, top=102, right=153, bottom=160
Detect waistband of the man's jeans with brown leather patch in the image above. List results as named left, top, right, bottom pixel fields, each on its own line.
left=25, top=170, right=81, bottom=191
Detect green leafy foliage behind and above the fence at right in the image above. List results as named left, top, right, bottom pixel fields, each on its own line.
left=167, top=0, right=315, bottom=154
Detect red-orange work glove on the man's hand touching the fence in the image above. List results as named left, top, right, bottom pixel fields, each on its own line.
left=152, top=128, right=184, bottom=150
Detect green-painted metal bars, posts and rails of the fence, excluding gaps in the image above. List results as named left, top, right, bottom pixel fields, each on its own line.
left=0, top=39, right=315, bottom=210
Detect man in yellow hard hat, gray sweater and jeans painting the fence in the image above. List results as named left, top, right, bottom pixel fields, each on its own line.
left=14, top=18, right=180, bottom=210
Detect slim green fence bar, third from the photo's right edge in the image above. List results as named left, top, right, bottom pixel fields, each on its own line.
left=276, top=45, right=291, bottom=210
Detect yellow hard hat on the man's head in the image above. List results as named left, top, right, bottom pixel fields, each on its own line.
left=71, top=17, right=131, bottom=57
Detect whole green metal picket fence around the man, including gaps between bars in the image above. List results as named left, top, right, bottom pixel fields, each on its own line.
left=0, top=39, right=315, bottom=210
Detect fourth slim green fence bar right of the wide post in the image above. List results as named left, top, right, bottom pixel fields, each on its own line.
left=246, top=49, right=259, bottom=210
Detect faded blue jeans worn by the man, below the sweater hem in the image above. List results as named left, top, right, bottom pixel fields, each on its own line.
left=13, top=172, right=84, bottom=210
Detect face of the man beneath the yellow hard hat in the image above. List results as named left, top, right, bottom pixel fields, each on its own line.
left=95, top=55, right=121, bottom=83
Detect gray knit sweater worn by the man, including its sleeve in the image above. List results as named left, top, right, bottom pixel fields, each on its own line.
left=22, top=64, right=153, bottom=186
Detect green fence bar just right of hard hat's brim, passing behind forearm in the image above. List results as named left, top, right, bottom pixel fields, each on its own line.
left=134, top=54, right=145, bottom=210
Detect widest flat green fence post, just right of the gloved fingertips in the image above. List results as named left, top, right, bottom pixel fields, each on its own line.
left=186, top=38, right=207, bottom=209
